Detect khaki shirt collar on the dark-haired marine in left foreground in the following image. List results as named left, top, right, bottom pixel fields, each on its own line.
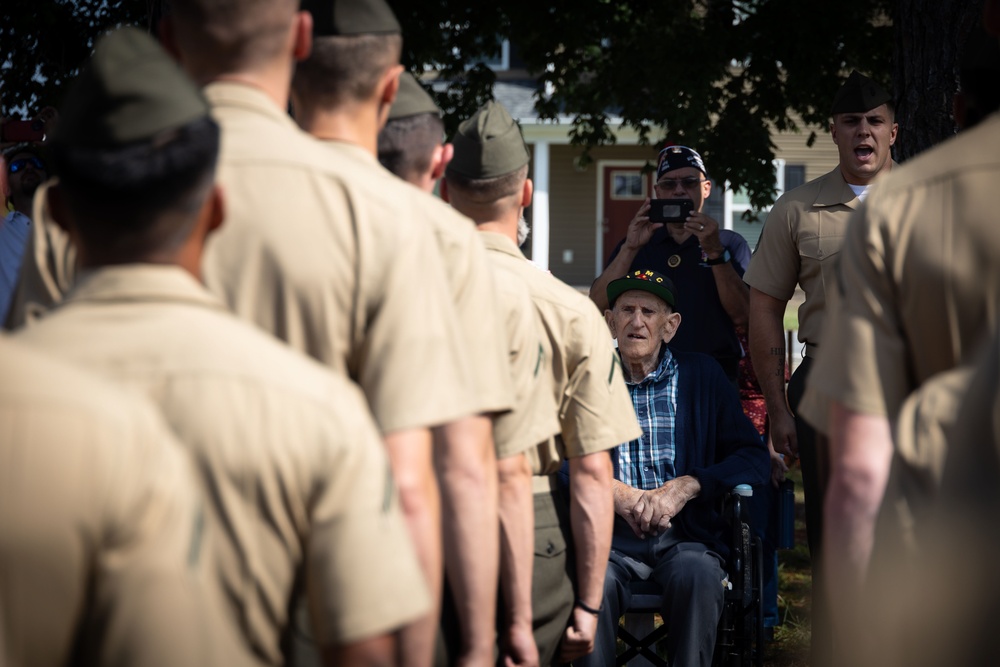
left=66, top=264, right=226, bottom=311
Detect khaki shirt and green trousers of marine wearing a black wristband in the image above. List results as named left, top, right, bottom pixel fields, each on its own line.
left=480, top=232, right=642, bottom=665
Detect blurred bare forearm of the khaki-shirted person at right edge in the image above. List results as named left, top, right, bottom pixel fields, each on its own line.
left=823, top=402, right=892, bottom=639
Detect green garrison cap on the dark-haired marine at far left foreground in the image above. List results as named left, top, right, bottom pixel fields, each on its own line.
left=53, top=28, right=209, bottom=148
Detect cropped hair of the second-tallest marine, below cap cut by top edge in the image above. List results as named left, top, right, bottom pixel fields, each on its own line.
left=292, top=34, right=403, bottom=107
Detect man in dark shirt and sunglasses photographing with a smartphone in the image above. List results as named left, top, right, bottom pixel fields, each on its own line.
left=590, top=146, right=750, bottom=383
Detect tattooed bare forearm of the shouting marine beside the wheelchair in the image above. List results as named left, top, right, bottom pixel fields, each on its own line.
left=749, top=289, right=788, bottom=414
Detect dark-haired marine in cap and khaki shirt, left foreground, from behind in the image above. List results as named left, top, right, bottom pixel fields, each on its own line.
left=19, top=29, right=428, bottom=665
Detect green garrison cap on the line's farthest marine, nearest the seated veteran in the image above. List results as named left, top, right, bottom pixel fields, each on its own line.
left=446, top=100, right=529, bottom=179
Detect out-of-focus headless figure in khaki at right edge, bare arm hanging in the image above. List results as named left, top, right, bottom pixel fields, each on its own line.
left=802, top=0, right=1000, bottom=664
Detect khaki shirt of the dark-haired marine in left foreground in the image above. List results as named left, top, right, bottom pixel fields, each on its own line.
left=18, top=264, right=429, bottom=665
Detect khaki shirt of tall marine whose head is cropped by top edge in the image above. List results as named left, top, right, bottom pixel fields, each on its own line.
left=203, top=83, right=482, bottom=433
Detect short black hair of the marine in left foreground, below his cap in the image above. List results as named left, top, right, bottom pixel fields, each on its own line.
left=52, top=118, right=220, bottom=257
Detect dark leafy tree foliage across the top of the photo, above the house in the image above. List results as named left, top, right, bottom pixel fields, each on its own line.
left=0, top=0, right=982, bottom=208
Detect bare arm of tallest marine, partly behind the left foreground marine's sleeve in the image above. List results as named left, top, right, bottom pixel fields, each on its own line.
left=384, top=429, right=443, bottom=667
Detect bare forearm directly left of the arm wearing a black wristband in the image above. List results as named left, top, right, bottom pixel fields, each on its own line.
left=497, top=454, right=535, bottom=629
